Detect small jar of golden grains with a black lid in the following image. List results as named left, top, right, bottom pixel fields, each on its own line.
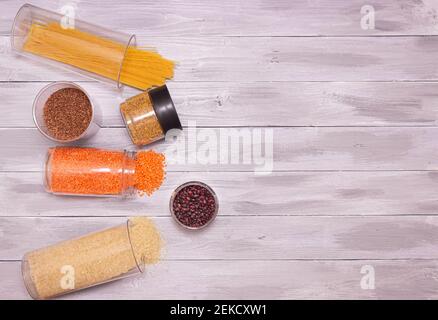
left=120, top=85, right=182, bottom=146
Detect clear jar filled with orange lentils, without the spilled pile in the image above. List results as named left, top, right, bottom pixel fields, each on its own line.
left=44, top=147, right=137, bottom=197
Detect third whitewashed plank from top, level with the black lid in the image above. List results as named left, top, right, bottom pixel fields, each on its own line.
left=4, top=82, right=438, bottom=127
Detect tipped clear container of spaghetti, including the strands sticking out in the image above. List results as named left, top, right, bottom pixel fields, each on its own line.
left=10, top=4, right=174, bottom=90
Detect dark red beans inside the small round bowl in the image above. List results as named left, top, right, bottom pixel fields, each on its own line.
left=172, top=184, right=216, bottom=228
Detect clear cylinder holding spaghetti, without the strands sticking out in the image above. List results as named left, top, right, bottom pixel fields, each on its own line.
left=11, top=4, right=136, bottom=88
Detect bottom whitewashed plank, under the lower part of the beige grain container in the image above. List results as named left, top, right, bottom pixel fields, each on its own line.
left=0, top=260, right=438, bottom=299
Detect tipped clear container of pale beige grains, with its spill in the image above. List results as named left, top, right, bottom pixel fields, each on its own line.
left=21, top=217, right=161, bottom=299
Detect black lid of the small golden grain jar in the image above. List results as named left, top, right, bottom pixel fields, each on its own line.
left=149, top=85, right=182, bottom=133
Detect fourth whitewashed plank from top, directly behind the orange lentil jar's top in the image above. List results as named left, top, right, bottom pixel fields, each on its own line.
left=0, top=127, right=438, bottom=173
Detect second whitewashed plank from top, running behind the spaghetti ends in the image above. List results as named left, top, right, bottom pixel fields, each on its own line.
left=4, top=36, right=438, bottom=82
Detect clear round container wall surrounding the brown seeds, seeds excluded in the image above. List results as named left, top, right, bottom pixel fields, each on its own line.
left=32, top=81, right=101, bottom=143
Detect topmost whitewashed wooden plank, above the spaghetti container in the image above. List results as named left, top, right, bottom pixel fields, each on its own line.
left=0, top=0, right=438, bottom=37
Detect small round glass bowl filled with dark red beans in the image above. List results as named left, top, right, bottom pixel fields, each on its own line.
left=169, top=181, right=219, bottom=230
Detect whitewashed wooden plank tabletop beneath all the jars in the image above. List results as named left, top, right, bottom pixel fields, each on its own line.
left=0, top=0, right=438, bottom=299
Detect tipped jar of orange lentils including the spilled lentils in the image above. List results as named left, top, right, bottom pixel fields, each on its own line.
left=44, top=147, right=165, bottom=197
